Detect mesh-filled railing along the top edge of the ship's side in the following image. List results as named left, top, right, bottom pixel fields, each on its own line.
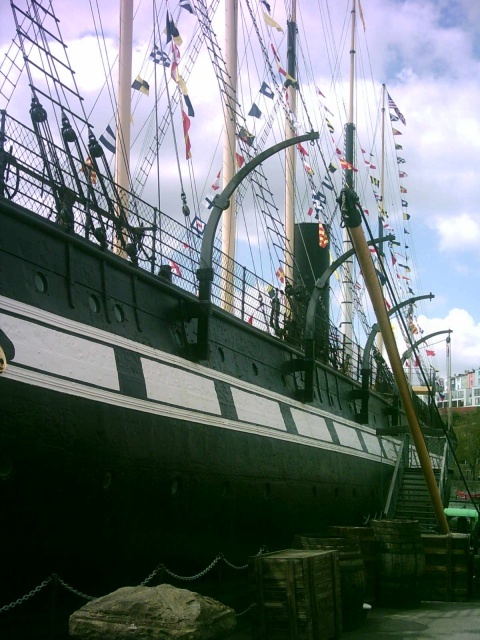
left=0, top=111, right=393, bottom=394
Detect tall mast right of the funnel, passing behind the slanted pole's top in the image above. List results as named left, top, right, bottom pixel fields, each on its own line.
left=342, top=0, right=356, bottom=355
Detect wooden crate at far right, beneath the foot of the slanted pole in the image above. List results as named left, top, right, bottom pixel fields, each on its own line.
left=422, top=533, right=471, bottom=602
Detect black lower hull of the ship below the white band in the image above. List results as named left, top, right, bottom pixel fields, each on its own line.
left=1, top=381, right=391, bottom=590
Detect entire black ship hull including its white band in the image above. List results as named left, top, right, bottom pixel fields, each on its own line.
left=0, top=198, right=397, bottom=600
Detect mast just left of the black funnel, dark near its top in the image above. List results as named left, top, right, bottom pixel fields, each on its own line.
left=284, top=0, right=297, bottom=284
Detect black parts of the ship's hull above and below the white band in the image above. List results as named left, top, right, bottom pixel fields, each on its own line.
left=0, top=202, right=393, bottom=620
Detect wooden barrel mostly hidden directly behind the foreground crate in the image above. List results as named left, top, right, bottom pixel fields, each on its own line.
left=293, top=534, right=365, bottom=630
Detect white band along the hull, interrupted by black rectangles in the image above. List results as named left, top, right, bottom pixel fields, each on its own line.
left=0, top=296, right=398, bottom=464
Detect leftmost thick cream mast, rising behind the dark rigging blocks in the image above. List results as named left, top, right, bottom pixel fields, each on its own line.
left=114, top=0, right=133, bottom=253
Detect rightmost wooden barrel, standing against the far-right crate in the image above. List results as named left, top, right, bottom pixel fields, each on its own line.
left=371, top=520, right=425, bottom=607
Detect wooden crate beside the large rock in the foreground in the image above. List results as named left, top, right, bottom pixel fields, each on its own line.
left=249, top=549, right=342, bottom=640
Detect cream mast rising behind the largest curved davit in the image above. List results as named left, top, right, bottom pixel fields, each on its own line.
left=222, top=0, right=238, bottom=311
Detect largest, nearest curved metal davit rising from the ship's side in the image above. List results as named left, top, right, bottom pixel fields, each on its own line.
left=194, top=131, right=319, bottom=360
